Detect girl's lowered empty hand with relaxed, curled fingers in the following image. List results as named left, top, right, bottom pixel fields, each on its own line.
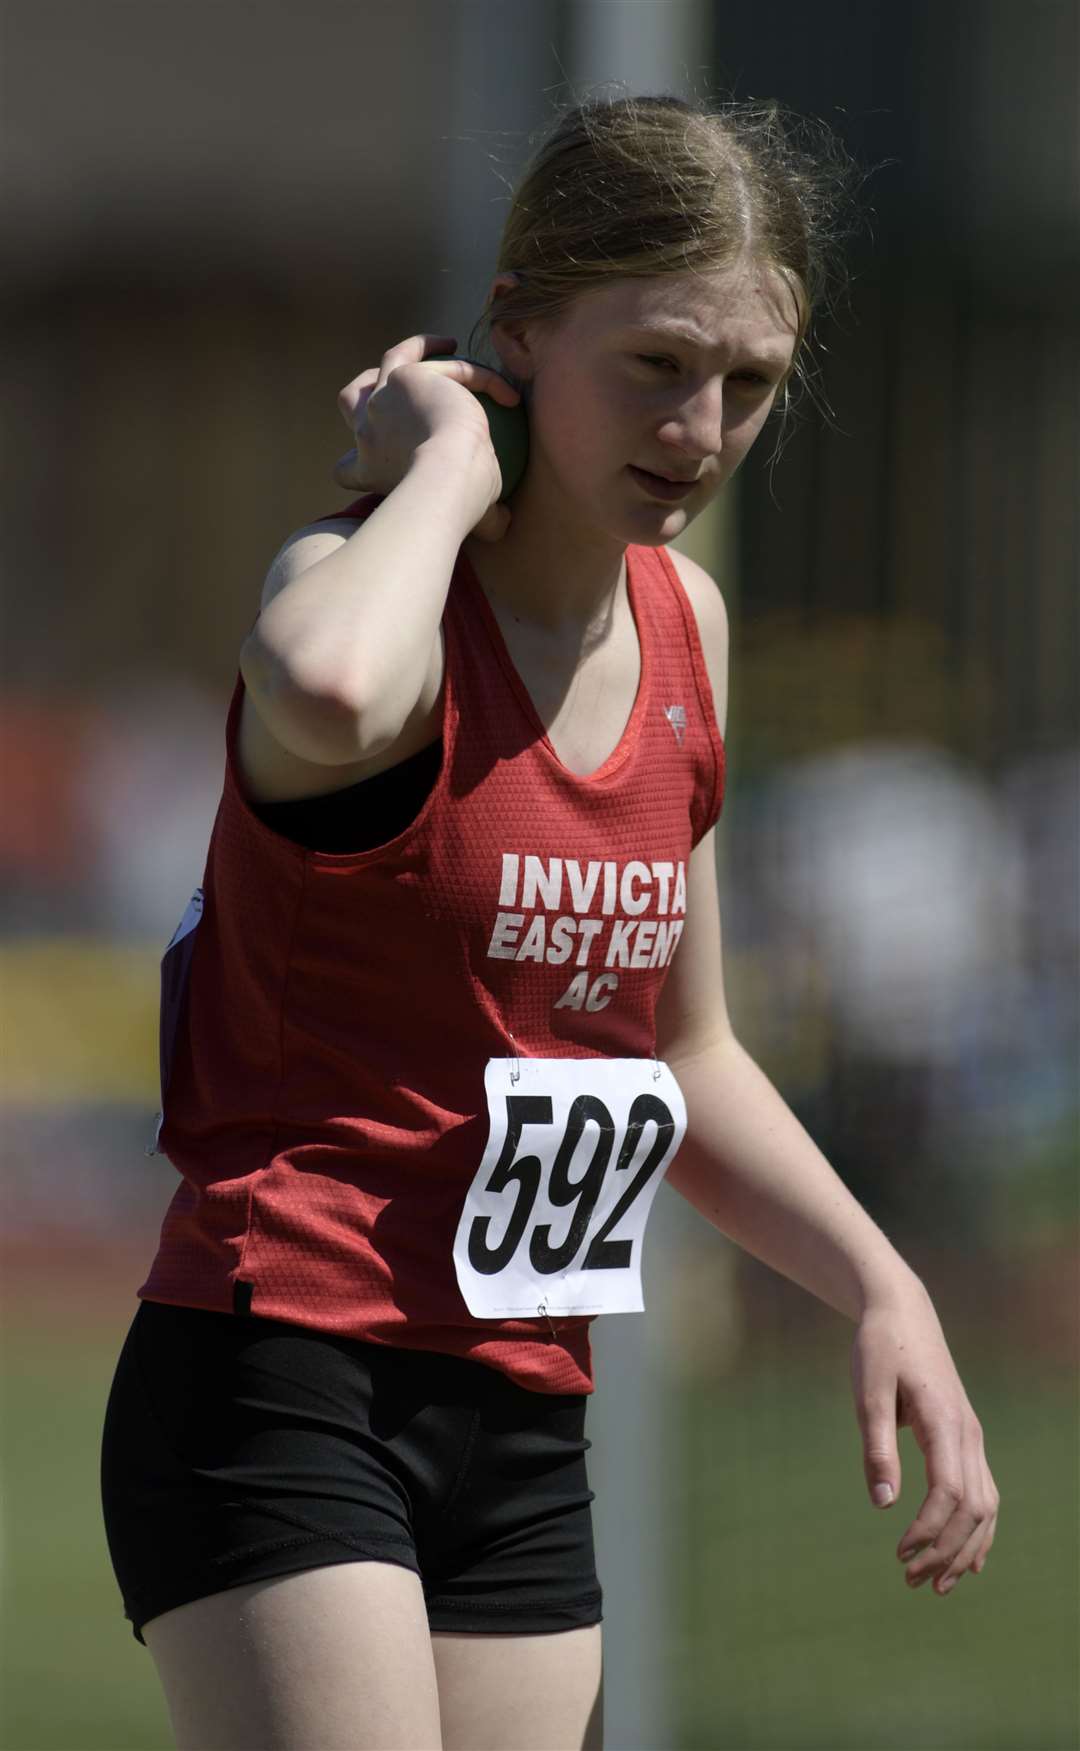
left=851, top=1285, right=999, bottom=1597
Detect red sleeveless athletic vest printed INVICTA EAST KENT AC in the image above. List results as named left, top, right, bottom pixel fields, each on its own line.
left=138, top=499, right=723, bottom=1392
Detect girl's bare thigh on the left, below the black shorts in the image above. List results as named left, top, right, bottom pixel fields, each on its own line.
left=144, top=1562, right=437, bottom=1751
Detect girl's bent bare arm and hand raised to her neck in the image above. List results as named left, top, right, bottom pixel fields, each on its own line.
left=240, top=336, right=515, bottom=765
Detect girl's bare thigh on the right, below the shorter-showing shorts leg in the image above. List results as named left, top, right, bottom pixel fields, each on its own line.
left=431, top=1623, right=604, bottom=1751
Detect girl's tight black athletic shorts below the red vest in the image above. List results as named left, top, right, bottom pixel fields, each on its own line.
left=102, top=1301, right=602, bottom=1641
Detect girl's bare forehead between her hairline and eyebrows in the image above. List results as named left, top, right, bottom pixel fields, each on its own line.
left=560, top=261, right=798, bottom=364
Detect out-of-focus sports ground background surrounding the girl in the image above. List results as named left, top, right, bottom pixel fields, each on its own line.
left=0, top=0, right=1080, bottom=1751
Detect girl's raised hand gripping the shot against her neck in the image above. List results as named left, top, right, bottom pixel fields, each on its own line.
left=334, top=334, right=520, bottom=541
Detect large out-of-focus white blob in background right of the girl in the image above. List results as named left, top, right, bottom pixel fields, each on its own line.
left=761, top=742, right=1024, bottom=1065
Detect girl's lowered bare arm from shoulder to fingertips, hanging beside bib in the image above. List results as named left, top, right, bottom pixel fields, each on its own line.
left=656, top=553, right=998, bottom=1595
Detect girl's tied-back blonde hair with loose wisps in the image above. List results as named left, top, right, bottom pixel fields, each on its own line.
left=469, top=96, right=856, bottom=425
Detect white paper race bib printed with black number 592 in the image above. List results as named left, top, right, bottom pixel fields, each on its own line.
left=453, top=1058, right=686, bottom=1319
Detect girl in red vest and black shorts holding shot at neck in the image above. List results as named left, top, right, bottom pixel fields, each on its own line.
left=103, top=98, right=998, bottom=1751
